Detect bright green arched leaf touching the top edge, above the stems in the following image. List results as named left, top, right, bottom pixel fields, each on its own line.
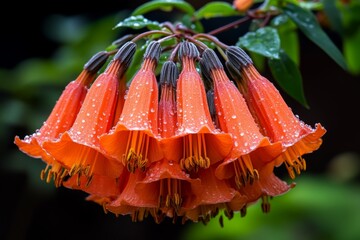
left=132, top=0, right=195, bottom=16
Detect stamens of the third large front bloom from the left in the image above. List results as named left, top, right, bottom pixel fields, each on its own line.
left=122, top=131, right=150, bottom=173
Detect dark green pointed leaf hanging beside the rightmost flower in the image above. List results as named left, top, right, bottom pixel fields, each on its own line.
left=268, top=51, right=309, bottom=108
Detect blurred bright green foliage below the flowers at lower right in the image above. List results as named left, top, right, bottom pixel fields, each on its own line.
left=183, top=174, right=360, bottom=240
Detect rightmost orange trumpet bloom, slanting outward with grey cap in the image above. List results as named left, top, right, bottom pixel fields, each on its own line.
left=226, top=47, right=326, bottom=178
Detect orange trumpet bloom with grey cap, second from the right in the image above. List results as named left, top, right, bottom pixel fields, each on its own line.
left=201, top=49, right=282, bottom=188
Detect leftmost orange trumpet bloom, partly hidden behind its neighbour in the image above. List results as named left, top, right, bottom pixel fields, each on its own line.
left=15, top=52, right=108, bottom=186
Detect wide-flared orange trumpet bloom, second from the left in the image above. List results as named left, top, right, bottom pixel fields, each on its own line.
left=43, top=42, right=135, bottom=185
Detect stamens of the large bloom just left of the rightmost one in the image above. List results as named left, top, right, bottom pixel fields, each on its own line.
left=233, top=155, right=259, bottom=188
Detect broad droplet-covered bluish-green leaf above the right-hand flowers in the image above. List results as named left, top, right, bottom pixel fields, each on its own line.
left=236, top=27, right=280, bottom=58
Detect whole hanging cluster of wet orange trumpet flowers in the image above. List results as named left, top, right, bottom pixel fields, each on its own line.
left=15, top=31, right=325, bottom=223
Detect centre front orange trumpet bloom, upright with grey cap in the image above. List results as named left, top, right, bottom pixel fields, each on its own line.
left=163, top=42, right=232, bottom=171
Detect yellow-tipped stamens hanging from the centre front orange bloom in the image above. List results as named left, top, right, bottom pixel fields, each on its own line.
left=180, top=133, right=210, bottom=171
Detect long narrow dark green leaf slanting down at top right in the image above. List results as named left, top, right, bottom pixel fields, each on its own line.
left=284, top=3, right=347, bottom=70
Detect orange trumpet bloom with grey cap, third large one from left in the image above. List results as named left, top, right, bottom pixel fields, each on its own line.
left=100, top=42, right=162, bottom=172
